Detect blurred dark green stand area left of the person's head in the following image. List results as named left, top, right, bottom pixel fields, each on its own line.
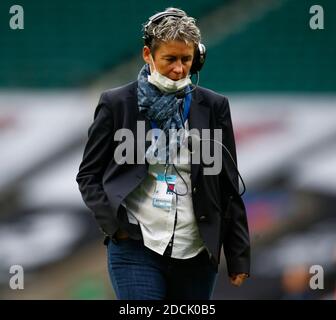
left=0, top=0, right=229, bottom=88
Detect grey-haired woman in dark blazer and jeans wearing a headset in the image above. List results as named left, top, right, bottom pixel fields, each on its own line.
left=77, top=8, right=250, bottom=299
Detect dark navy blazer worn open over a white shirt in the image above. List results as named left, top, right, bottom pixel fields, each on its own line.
left=76, top=81, right=250, bottom=274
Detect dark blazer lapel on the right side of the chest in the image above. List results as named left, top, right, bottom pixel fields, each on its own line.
left=189, top=89, right=210, bottom=185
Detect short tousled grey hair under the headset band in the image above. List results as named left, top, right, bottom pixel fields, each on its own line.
left=144, top=8, right=201, bottom=52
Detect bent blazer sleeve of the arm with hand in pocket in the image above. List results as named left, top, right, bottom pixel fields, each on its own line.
left=76, top=93, right=118, bottom=235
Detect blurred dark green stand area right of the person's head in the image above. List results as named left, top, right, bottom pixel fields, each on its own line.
left=202, top=0, right=336, bottom=92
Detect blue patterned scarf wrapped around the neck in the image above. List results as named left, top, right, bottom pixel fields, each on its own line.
left=138, top=64, right=183, bottom=160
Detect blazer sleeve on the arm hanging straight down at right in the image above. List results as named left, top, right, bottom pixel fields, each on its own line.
left=218, top=98, right=250, bottom=275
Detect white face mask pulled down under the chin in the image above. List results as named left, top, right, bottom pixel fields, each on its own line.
left=148, top=55, right=191, bottom=93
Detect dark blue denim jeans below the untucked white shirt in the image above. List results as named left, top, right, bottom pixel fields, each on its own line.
left=107, top=238, right=217, bottom=300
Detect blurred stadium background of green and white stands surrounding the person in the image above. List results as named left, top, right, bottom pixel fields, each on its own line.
left=0, top=0, right=336, bottom=299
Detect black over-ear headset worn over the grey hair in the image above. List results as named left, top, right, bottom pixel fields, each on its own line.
left=142, top=11, right=206, bottom=74
